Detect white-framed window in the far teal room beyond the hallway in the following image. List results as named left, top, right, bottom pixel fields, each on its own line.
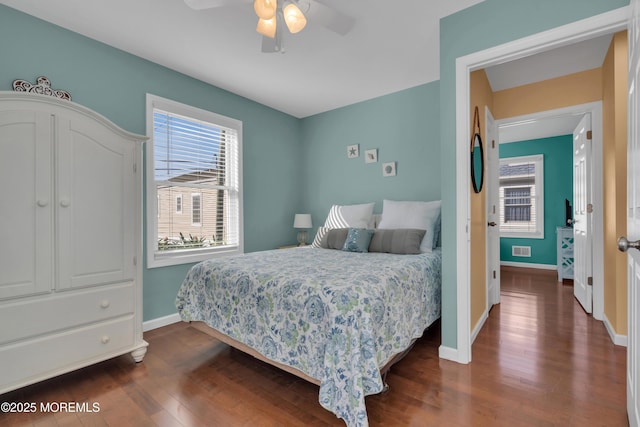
left=500, top=154, right=544, bottom=239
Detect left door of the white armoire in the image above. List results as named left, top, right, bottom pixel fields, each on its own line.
left=0, top=110, right=53, bottom=299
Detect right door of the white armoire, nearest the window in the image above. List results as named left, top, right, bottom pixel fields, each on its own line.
left=56, top=118, right=135, bottom=289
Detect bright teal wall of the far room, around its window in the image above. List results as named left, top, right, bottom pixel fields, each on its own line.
left=500, top=135, right=573, bottom=266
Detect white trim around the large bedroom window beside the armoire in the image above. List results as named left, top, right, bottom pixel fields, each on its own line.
left=145, top=93, right=244, bottom=268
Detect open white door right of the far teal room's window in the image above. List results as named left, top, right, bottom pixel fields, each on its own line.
left=573, top=114, right=593, bottom=313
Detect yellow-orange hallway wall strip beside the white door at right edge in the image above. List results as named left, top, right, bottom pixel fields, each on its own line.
left=602, top=32, right=627, bottom=335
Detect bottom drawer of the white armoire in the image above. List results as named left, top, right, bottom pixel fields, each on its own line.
left=0, top=316, right=135, bottom=393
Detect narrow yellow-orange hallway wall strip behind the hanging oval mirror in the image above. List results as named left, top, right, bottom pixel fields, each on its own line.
left=469, top=70, right=493, bottom=330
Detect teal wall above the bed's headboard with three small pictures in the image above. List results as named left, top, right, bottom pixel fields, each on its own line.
left=302, top=82, right=440, bottom=228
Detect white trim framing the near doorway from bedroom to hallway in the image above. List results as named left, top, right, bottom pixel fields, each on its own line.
left=448, top=6, right=629, bottom=363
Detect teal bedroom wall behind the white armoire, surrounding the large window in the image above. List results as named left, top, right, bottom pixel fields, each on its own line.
left=0, top=5, right=303, bottom=320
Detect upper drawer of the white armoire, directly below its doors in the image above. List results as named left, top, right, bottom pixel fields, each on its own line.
left=0, top=282, right=135, bottom=344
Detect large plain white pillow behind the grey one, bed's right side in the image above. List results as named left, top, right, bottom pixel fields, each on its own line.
left=378, top=200, right=442, bottom=252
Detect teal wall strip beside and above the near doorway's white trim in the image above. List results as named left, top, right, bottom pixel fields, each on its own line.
left=440, top=0, right=629, bottom=349
